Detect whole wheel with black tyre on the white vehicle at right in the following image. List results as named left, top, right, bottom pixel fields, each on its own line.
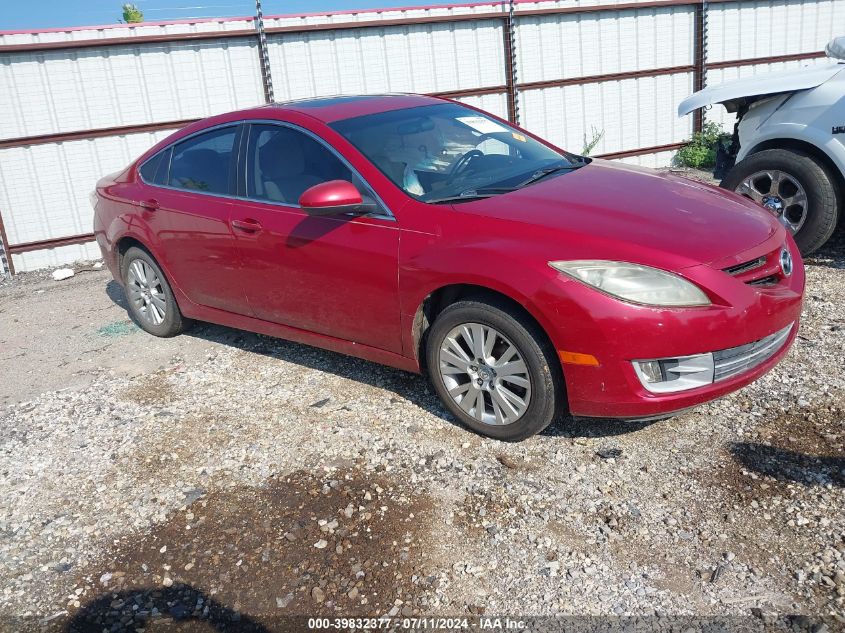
left=720, top=149, right=840, bottom=255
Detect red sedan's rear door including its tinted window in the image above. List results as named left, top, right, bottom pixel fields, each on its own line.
left=140, top=124, right=250, bottom=314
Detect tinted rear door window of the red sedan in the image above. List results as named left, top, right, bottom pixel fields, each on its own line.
left=168, top=127, right=237, bottom=194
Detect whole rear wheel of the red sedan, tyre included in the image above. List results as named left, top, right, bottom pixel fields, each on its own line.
left=120, top=246, right=191, bottom=338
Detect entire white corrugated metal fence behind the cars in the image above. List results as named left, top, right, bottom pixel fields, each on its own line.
left=0, top=0, right=845, bottom=270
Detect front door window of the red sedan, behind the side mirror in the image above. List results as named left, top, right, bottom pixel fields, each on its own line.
left=246, top=124, right=360, bottom=204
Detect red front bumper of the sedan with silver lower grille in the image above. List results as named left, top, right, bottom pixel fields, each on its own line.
left=542, top=235, right=804, bottom=418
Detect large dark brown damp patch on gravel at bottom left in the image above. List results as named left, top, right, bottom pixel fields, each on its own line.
left=56, top=468, right=442, bottom=631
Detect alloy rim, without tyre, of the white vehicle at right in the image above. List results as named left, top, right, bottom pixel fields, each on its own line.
left=735, top=169, right=807, bottom=235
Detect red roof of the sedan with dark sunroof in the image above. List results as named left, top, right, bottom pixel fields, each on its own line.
left=259, top=94, right=443, bottom=123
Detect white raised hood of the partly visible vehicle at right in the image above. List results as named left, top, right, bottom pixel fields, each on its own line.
left=678, top=63, right=845, bottom=116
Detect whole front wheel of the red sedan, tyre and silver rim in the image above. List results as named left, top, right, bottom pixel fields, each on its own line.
left=425, top=298, right=565, bottom=442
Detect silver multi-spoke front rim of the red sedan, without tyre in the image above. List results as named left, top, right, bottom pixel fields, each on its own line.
left=439, top=323, right=531, bottom=426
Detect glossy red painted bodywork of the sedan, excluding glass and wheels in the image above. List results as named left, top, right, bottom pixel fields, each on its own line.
left=95, top=96, right=804, bottom=417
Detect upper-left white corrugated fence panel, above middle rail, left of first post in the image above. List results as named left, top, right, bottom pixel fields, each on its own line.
left=0, top=40, right=263, bottom=138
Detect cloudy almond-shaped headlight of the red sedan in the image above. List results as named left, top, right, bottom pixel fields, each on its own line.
left=549, top=259, right=710, bottom=306
